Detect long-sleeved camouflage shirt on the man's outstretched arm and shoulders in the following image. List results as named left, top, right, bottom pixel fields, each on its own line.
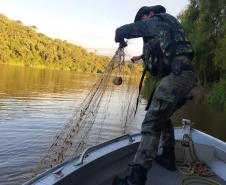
left=115, top=13, right=193, bottom=60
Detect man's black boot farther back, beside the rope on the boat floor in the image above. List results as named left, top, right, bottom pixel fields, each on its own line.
left=155, top=147, right=177, bottom=171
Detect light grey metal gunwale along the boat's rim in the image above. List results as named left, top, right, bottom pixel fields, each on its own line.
left=24, top=127, right=226, bottom=185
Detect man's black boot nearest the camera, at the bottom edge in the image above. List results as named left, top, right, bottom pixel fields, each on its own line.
left=112, top=164, right=147, bottom=185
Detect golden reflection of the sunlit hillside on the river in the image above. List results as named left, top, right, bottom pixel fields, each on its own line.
left=0, top=65, right=98, bottom=98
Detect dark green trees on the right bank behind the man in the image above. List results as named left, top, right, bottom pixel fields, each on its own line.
left=178, top=0, right=226, bottom=109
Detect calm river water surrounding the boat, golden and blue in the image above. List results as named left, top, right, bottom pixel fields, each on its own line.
left=0, top=65, right=226, bottom=185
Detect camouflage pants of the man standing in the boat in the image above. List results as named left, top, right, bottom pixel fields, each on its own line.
left=133, top=68, right=196, bottom=168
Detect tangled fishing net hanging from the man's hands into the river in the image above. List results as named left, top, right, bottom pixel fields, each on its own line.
left=33, top=49, right=139, bottom=175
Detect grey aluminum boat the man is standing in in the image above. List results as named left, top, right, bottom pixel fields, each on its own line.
left=25, top=119, right=226, bottom=185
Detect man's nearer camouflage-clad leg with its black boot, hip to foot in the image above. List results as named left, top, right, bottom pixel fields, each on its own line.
left=113, top=72, right=195, bottom=185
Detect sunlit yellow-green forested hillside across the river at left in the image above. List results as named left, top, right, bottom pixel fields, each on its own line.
left=0, top=14, right=109, bottom=72
